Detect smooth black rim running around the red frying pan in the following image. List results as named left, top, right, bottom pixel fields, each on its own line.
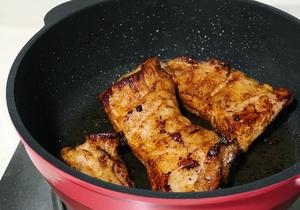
left=6, top=0, right=300, bottom=199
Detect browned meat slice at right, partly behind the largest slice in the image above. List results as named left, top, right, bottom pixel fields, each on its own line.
left=165, top=57, right=293, bottom=151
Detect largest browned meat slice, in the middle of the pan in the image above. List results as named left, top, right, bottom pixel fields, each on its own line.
left=99, top=58, right=234, bottom=192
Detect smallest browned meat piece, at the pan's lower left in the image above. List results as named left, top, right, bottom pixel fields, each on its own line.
left=60, top=133, right=134, bottom=187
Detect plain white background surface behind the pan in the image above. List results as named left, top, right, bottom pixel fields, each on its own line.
left=0, top=0, right=300, bottom=179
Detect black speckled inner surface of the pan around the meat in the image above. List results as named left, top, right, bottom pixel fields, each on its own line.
left=14, top=0, right=300, bottom=189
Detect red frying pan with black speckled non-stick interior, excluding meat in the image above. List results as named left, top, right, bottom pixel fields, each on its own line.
left=7, top=0, right=300, bottom=209
